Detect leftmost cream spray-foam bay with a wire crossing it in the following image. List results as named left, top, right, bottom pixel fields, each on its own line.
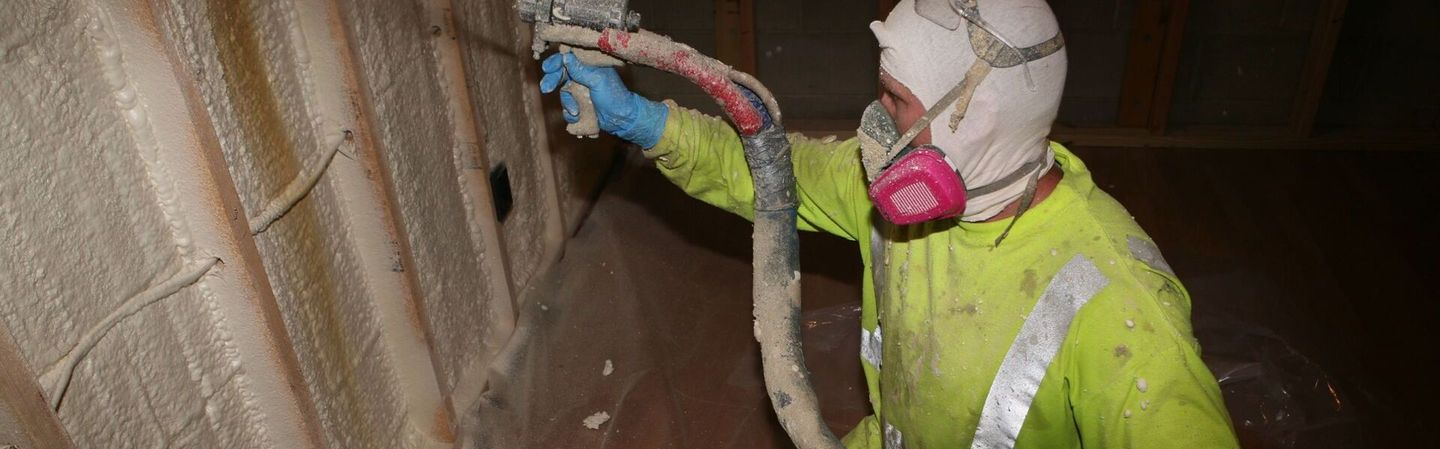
left=0, top=1, right=250, bottom=448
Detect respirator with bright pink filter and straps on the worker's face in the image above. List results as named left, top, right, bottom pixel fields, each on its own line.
left=857, top=0, right=1064, bottom=225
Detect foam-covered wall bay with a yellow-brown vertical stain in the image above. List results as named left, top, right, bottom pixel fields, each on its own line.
left=154, top=0, right=432, bottom=448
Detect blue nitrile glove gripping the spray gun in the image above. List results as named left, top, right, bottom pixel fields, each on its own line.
left=540, top=53, right=670, bottom=148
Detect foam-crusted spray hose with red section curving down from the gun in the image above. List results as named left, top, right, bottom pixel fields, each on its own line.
left=536, top=23, right=842, bottom=449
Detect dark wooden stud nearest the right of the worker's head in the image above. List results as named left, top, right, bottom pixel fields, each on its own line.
left=1116, top=0, right=1189, bottom=135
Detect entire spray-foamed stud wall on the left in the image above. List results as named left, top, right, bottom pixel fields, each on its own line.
left=0, top=0, right=611, bottom=449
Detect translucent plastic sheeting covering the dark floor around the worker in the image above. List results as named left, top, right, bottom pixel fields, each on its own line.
left=465, top=155, right=1362, bottom=449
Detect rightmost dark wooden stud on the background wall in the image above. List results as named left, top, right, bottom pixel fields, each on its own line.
left=1290, top=0, right=1349, bottom=137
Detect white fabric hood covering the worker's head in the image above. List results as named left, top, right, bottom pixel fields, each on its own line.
left=870, top=0, right=1066, bottom=222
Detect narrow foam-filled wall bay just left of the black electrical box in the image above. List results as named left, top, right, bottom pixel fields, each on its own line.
left=341, top=0, right=520, bottom=402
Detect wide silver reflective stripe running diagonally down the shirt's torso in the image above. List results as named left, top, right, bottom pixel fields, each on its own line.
left=971, top=255, right=1110, bottom=449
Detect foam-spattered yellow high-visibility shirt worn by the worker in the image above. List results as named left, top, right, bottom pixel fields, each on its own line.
left=647, top=102, right=1237, bottom=449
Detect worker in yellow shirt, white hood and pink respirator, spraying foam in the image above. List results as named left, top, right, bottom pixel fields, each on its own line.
left=541, top=0, right=1237, bottom=449
